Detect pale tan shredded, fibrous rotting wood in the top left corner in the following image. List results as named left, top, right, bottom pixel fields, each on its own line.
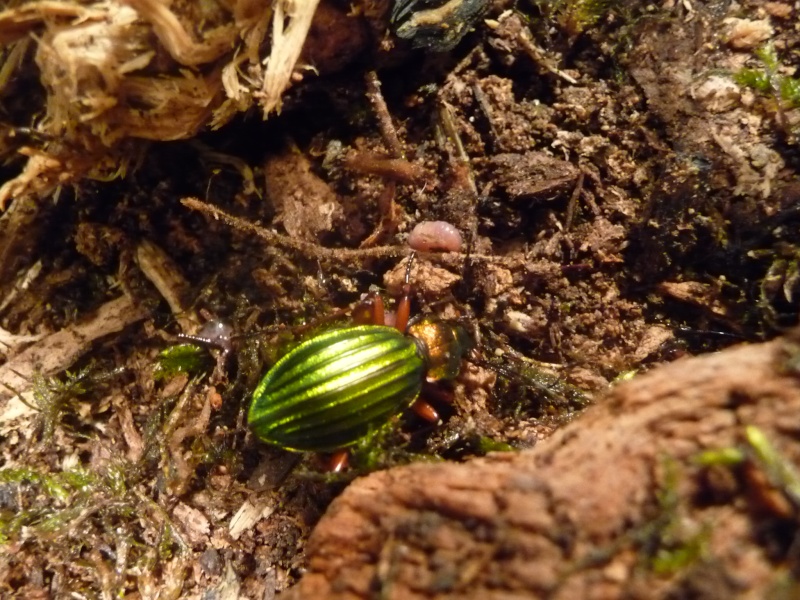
left=0, top=0, right=378, bottom=208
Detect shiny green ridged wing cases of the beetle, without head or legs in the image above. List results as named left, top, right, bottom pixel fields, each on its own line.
left=248, top=325, right=428, bottom=452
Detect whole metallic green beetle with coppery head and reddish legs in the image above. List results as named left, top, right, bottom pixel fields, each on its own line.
left=247, top=260, right=471, bottom=471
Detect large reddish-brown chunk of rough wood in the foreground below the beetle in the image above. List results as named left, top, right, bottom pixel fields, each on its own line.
left=288, top=341, right=800, bottom=600
